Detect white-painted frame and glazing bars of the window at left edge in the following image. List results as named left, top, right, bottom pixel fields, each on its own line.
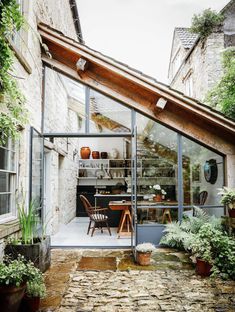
left=0, top=139, right=17, bottom=223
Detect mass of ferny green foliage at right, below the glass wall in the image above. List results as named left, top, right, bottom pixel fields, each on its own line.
left=160, top=208, right=235, bottom=279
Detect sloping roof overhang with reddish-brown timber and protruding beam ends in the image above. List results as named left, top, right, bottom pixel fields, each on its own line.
left=39, top=24, right=235, bottom=154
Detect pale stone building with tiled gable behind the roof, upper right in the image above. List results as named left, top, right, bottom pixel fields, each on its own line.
left=168, top=0, right=235, bottom=101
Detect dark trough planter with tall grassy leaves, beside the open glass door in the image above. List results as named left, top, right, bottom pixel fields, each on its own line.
left=5, top=201, right=51, bottom=272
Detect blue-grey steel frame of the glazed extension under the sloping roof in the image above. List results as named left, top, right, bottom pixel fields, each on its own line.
left=38, top=63, right=225, bottom=244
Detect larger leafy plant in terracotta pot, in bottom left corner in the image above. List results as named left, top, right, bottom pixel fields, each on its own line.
left=0, top=255, right=42, bottom=312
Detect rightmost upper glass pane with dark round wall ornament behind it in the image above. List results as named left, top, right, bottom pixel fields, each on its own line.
left=182, top=137, right=224, bottom=207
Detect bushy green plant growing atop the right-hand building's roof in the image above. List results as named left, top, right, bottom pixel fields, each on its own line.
left=190, top=9, right=224, bottom=40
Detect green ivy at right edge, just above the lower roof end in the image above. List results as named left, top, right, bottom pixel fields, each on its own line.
left=206, top=47, right=235, bottom=120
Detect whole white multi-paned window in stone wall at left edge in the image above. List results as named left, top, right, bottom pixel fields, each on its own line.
left=0, top=140, right=16, bottom=220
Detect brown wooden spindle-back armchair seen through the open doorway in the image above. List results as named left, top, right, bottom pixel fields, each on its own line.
left=80, top=195, right=112, bottom=236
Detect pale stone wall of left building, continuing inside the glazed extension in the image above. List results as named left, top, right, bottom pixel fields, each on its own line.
left=0, top=0, right=82, bottom=255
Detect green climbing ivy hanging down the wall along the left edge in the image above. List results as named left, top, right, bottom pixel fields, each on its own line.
left=0, top=0, right=27, bottom=145
